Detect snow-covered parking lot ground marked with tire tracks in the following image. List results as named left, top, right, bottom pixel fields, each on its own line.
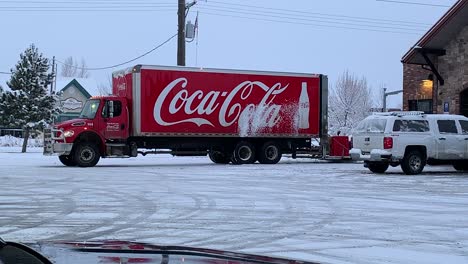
left=0, top=148, right=468, bottom=263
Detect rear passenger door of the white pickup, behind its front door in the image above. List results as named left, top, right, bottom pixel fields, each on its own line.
left=436, top=119, right=465, bottom=160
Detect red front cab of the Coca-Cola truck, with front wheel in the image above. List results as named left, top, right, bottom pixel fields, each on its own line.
left=44, top=96, right=136, bottom=167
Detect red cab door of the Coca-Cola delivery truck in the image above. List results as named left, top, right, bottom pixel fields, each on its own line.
left=102, top=99, right=128, bottom=139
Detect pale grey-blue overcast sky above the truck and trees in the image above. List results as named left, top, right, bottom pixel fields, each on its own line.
left=0, top=0, right=456, bottom=106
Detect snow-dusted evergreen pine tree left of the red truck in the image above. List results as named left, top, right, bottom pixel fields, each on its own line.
left=2, top=44, right=60, bottom=152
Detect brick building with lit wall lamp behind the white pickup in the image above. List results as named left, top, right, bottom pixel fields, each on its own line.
left=402, top=0, right=468, bottom=116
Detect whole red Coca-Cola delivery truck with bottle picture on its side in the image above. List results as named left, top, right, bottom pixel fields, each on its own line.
left=44, top=65, right=336, bottom=167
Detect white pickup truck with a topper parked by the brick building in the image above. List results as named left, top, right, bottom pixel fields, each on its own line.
left=350, top=112, right=468, bottom=174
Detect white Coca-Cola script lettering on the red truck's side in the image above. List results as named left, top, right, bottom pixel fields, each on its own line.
left=153, top=78, right=289, bottom=127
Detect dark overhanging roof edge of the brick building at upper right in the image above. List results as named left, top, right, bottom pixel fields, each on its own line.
left=401, top=0, right=468, bottom=64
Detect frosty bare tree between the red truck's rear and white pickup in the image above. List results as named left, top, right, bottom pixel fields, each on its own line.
left=329, top=70, right=373, bottom=134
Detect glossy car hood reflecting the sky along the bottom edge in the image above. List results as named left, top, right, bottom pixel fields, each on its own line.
left=29, top=241, right=316, bottom=264
